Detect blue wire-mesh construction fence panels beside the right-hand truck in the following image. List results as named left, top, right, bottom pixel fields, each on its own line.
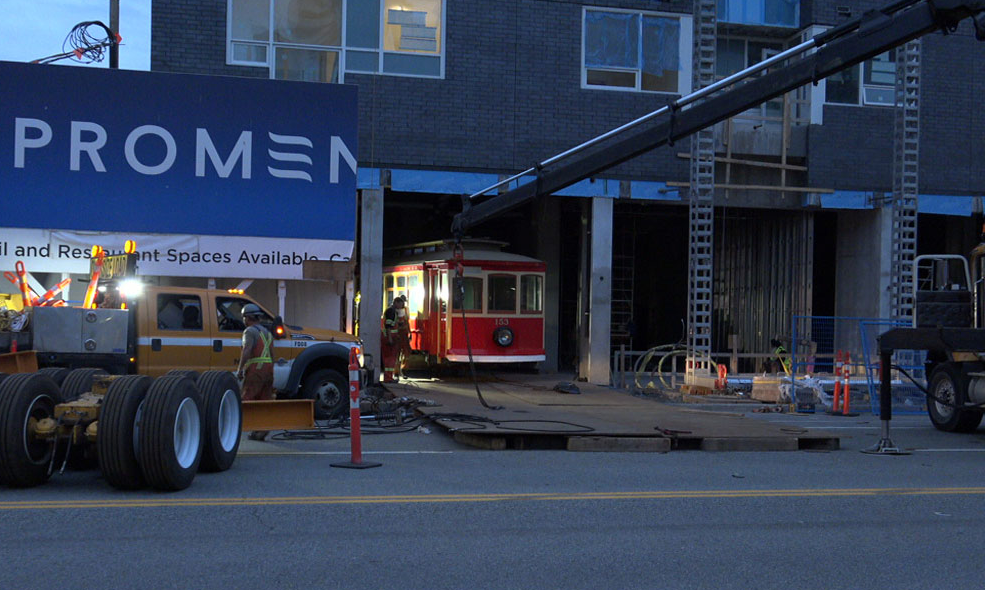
left=784, top=316, right=927, bottom=414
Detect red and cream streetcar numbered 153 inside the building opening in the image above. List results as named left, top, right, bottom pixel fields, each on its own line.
left=383, top=240, right=546, bottom=364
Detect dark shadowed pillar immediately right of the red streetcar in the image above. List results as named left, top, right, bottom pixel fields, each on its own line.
left=534, top=197, right=561, bottom=373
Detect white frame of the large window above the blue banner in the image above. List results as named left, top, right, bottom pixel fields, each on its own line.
left=226, top=0, right=448, bottom=84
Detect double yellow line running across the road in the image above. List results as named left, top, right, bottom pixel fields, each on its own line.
left=0, top=487, right=985, bottom=511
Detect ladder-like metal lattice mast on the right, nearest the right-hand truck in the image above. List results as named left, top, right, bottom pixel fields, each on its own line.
left=890, top=40, right=920, bottom=320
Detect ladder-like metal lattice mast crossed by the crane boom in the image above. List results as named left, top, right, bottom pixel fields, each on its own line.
left=685, top=0, right=718, bottom=385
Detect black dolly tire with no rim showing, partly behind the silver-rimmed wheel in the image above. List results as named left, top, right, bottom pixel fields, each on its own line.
left=96, top=375, right=154, bottom=490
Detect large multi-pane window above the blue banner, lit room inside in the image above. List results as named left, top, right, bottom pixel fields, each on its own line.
left=226, top=0, right=446, bottom=82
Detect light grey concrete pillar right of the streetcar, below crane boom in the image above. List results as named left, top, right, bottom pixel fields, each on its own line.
left=588, top=197, right=612, bottom=385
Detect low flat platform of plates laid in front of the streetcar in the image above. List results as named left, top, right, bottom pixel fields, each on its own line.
left=378, top=373, right=840, bottom=452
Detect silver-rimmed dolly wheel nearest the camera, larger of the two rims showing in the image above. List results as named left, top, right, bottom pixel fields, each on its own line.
left=137, top=375, right=202, bottom=491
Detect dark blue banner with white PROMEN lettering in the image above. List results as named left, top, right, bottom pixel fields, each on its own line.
left=0, top=62, right=358, bottom=242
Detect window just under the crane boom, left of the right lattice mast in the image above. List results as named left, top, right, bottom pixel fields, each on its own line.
left=825, top=50, right=896, bottom=106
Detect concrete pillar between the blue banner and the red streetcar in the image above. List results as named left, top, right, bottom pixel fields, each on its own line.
left=358, top=188, right=383, bottom=382
